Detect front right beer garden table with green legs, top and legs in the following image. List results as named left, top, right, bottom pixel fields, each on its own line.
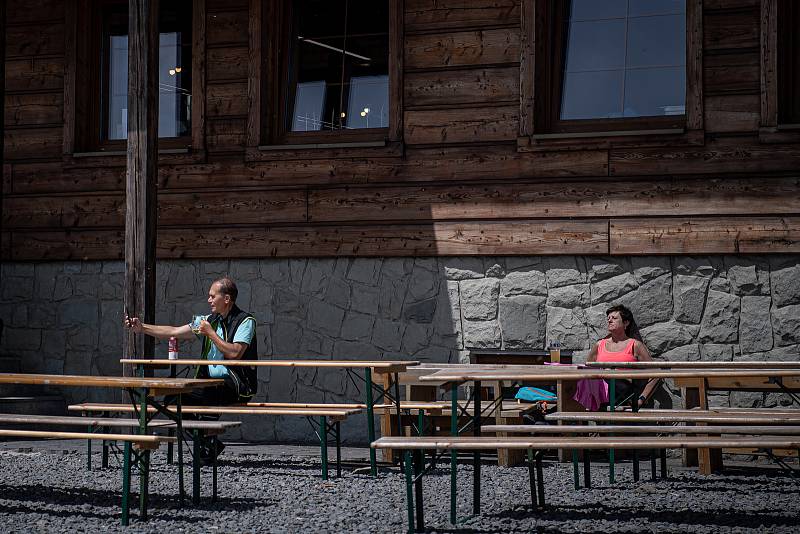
left=419, top=362, right=800, bottom=515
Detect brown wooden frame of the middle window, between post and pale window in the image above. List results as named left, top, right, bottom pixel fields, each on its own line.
left=247, top=0, right=403, bottom=160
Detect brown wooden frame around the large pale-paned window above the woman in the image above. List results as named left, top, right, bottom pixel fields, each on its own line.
left=518, top=0, right=704, bottom=150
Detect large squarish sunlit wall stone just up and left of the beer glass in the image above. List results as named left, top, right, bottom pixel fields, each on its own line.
left=498, top=295, right=547, bottom=349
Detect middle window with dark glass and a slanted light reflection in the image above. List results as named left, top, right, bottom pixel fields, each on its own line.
left=253, top=0, right=402, bottom=148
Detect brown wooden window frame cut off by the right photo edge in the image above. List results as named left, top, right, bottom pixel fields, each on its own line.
left=759, top=0, right=800, bottom=143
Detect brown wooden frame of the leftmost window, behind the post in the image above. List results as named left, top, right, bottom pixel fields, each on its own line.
left=63, top=0, right=206, bottom=161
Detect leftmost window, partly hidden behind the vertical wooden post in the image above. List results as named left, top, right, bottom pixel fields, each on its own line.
left=64, top=0, right=205, bottom=155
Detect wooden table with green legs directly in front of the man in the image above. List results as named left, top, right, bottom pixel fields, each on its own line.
left=120, top=359, right=419, bottom=476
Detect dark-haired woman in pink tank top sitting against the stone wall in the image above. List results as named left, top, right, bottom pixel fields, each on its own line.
left=586, top=304, right=658, bottom=407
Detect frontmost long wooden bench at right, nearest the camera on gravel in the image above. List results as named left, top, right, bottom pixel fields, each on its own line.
left=371, top=435, right=800, bottom=532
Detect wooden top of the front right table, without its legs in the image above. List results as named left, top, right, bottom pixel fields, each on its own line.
left=419, top=365, right=800, bottom=382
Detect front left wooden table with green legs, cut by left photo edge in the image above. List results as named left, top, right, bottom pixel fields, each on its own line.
left=0, top=373, right=225, bottom=525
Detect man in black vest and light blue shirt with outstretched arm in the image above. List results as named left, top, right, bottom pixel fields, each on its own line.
left=125, top=277, right=258, bottom=463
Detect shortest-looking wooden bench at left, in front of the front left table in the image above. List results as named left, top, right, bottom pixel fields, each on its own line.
left=0, top=429, right=176, bottom=526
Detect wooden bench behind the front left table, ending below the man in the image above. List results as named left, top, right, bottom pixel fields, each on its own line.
left=0, top=414, right=241, bottom=504
